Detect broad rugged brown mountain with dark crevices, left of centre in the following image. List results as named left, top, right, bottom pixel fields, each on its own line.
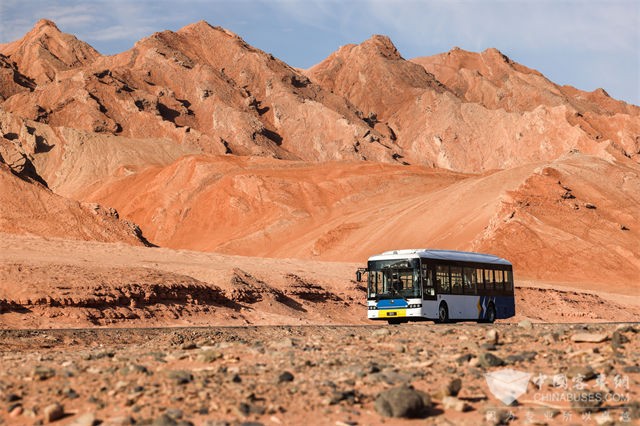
left=4, top=22, right=395, bottom=161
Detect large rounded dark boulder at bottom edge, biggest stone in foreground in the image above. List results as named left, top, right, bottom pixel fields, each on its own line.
left=374, top=385, right=431, bottom=418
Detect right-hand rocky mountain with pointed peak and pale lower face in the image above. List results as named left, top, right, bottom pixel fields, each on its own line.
left=308, top=36, right=640, bottom=172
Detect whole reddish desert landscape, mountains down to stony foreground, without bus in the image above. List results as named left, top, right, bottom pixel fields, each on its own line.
left=0, top=20, right=640, bottom=425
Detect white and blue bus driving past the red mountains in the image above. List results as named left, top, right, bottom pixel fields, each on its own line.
left=356, top=249, right=515, bottom=324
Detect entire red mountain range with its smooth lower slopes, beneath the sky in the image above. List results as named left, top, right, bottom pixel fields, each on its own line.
left=0, top=20, right=640, bottom=288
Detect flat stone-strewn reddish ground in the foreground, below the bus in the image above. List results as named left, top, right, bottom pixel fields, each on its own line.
left=0, top=322, right=640, bottom=426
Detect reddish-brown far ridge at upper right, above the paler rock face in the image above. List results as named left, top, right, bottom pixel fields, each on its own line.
left=412, top=48, right=640, bottom=157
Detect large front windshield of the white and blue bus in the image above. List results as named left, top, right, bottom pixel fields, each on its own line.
left=367, top=259, right=421, bottom=300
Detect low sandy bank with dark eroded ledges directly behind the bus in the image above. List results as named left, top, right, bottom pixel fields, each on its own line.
left=0, top=234, right=640, bottom=328
